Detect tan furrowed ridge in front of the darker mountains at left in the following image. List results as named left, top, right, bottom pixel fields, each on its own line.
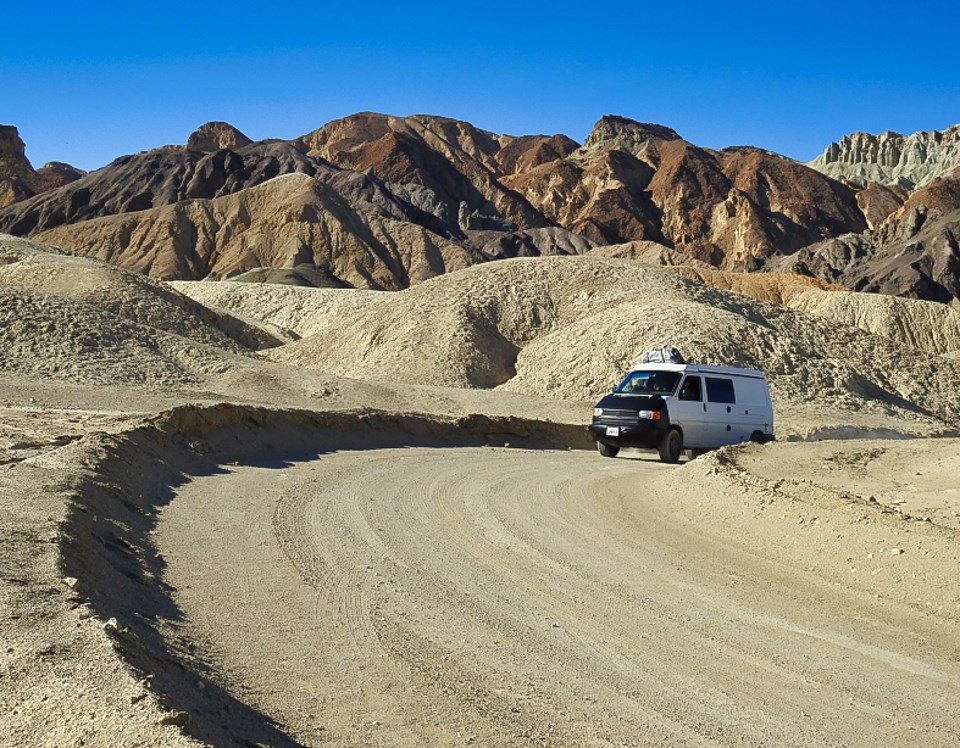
left=34, top=172, right=591, bottom=290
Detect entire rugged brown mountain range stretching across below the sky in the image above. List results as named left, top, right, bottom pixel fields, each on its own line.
left=0, top=113, right=960, bottom=299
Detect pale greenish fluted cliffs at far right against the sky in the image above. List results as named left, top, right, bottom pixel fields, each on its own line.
left=809, top=125, right=960, bottom=190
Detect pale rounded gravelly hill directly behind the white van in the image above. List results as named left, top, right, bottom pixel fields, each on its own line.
left=246, top=257, right=960, bottom=433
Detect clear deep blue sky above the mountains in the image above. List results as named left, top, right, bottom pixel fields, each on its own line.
left=0, top=0, right=960, bottom=170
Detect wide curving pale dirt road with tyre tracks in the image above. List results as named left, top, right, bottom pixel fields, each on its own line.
left=156, top=448, right=960, bottom=746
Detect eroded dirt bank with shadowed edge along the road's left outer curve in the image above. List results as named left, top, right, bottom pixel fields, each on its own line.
left=0, top=405, right=585, bottom=746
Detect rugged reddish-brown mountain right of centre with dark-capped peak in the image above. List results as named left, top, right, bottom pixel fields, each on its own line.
left=502, top=116, right=866, bottom=269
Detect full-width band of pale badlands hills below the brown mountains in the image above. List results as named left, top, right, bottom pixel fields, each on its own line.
left=0, top=238, right=960, bottom=436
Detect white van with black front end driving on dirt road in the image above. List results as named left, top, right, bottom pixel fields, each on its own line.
left=590, top=363, right=774, bottom=462
